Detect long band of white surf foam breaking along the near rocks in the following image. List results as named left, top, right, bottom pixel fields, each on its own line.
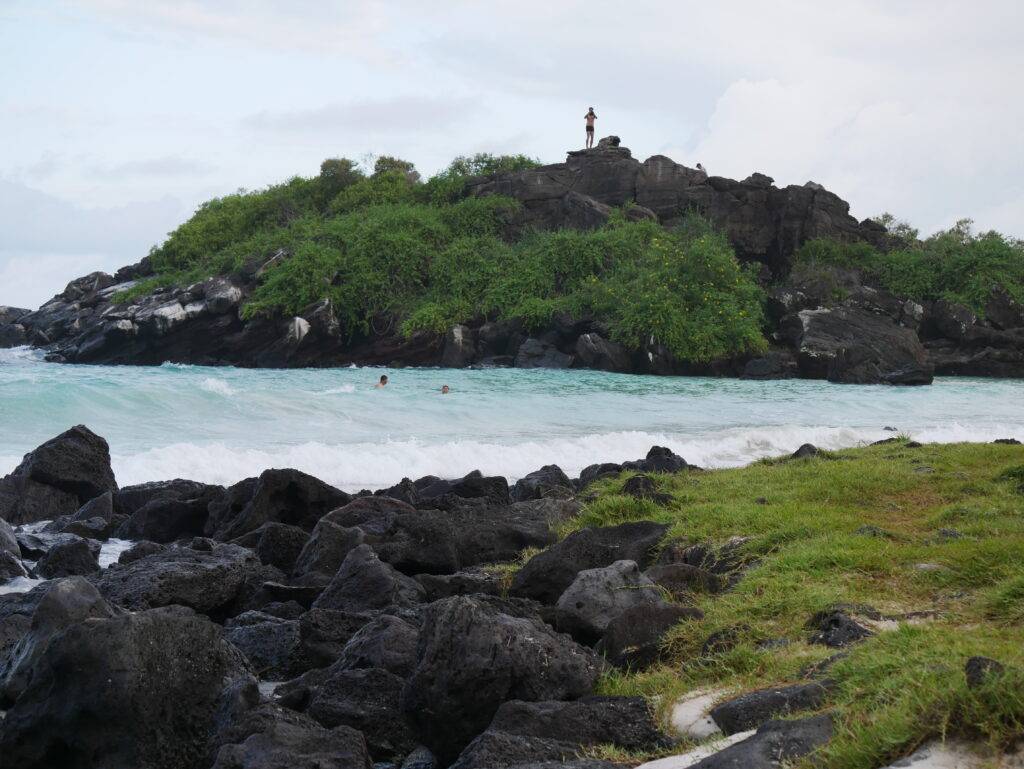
left=108, top=424, right=1024, bottom=490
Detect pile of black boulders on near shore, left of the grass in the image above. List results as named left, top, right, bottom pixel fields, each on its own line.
left=0, top=426, right=806, bottom=769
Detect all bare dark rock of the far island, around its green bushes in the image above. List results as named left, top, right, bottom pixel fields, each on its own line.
left=0, top=137, right=1024, bottom=384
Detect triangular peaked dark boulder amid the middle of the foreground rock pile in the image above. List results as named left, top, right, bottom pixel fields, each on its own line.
left=313, top=545, right=426, bottom=612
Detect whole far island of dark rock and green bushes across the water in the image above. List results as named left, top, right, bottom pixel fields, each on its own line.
left=0, top=137, right=1024, bottom=384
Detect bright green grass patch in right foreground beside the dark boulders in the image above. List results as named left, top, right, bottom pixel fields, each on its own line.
left=548, top=440, right=1024, bottom=769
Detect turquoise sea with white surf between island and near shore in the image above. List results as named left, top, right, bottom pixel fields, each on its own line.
left=0, top=348, right=1024, bottom=489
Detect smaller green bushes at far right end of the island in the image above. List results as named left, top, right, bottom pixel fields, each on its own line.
left=796, top=219, right=1024, bottom=311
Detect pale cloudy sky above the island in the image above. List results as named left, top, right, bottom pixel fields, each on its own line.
left=0, top=0, right=1024, bottom=307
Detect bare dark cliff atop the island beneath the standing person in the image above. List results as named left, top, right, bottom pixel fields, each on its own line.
left=470, top=136, right=887, bottom=276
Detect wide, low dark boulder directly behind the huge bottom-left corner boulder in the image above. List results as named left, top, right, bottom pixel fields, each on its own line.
left=97, top=545, right=263, bottom=617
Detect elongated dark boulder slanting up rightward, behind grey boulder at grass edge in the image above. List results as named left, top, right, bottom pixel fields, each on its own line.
left=511, top=521, right=669, bottom=603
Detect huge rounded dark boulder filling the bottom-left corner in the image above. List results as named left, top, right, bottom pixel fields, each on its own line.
left=0, top=607, right=255, bottom=769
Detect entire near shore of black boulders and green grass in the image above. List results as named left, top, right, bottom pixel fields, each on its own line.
left=0, top=426, right=1024, bottom=769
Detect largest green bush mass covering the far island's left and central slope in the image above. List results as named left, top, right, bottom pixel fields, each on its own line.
left=132, top=155, right=764, bottom=360
